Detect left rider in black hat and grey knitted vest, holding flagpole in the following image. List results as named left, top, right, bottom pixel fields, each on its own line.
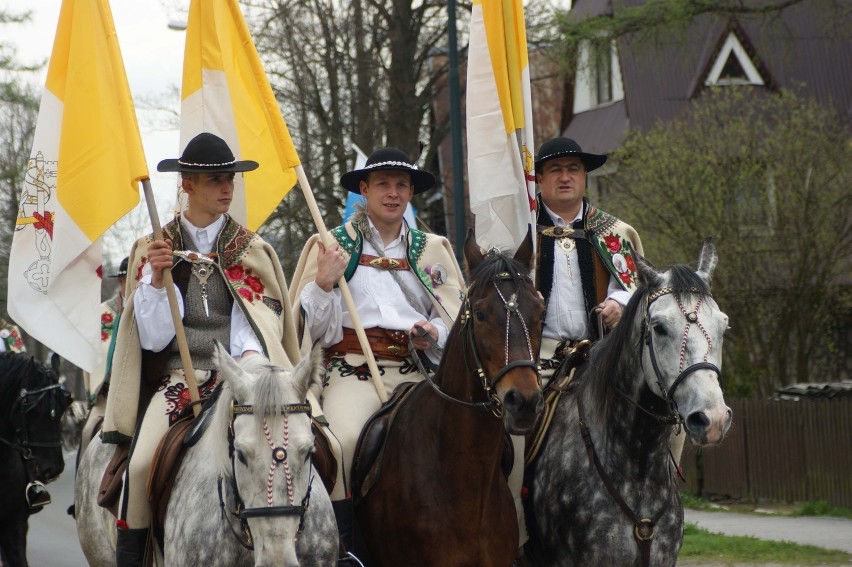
left=103, top=133, right=299, bottom=567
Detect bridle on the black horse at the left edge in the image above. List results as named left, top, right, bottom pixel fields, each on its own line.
left=0, top=384, right=67, bottom=511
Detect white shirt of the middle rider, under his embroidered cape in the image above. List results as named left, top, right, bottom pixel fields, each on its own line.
left=299, top=217, right=448, bottom=362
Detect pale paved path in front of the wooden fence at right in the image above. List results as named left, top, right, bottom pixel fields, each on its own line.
left=684, top=510, right=852, bottom=553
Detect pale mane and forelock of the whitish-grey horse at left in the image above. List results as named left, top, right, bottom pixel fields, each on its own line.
left=204, top=355, right=296, bottom=476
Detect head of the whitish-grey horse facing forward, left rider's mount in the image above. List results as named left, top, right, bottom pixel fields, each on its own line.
left=215, top=343, right=322, bottom=566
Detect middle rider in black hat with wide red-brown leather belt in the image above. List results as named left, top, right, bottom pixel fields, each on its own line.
left=291, top=148, right=464, bottom=564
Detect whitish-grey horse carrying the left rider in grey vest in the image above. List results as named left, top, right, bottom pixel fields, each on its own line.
left=76, top=345, right=338, bottom=567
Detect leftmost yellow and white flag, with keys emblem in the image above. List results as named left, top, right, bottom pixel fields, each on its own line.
left=8, top=0, right=148, bottom=371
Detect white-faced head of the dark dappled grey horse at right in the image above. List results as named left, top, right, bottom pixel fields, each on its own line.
left=635, top=238, right=731, bottom=445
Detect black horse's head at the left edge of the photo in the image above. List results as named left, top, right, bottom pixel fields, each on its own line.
left=0, top=352, right=71, bottom=482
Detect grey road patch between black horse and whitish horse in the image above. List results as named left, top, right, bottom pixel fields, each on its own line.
left=27, top=452, right=88, bottom=567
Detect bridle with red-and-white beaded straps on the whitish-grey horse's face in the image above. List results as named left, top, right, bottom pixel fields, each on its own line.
left=217, top=402, right=313, bottom=550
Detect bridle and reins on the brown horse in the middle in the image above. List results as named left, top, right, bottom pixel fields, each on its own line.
left=411, top=271, right=541, bottom=417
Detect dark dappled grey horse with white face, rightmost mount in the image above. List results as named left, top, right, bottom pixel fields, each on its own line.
left=525, top=238, right=731, bottom=567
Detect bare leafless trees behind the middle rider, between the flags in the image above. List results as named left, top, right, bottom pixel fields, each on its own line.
left=246, top=0, right=456, bottom=271
